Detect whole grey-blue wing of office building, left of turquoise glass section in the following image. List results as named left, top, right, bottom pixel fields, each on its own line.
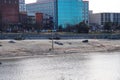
left=26, top=0, right=57, bottom=28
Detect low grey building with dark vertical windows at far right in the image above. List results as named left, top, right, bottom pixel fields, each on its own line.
left=89, top=12, right=120, bottom=25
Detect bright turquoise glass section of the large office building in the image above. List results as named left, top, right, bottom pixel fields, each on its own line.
left=58, top=0, right=83, bottom=27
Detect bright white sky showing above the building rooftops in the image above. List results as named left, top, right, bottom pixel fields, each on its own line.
left=26, top=0, right=120, bottom=13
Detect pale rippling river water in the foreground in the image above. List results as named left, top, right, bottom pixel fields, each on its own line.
left=0, top=53, right=120, bottom=80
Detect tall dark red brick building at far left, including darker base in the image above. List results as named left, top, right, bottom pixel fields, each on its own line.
left=0, top=0, right=19, bottom=32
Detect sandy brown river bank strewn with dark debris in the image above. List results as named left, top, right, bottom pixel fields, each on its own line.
left=0, top=39, right=120, bottom=58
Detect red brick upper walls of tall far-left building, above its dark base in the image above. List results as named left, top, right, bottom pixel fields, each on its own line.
left=0, top=0, right=19, bottom=24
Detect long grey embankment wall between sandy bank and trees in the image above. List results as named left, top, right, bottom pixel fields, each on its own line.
left=0, top=33, right=120, bottom=39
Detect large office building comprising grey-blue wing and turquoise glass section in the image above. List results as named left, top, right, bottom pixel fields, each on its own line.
left=26, top=0, right=89, bottom=29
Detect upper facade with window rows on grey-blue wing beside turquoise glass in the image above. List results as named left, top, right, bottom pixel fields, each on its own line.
left=26, top=0, right=55, bottom=18
